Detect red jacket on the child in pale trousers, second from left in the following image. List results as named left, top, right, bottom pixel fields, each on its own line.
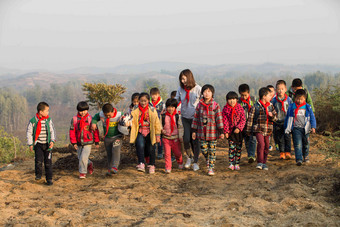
left=70, top=114, right=99, bottom=146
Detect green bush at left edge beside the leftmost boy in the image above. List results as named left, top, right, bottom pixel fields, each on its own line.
left=0, top=128, right=33, bottom=163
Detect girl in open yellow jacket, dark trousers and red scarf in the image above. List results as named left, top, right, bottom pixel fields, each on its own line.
left=130, top=92, right=161, bottom=174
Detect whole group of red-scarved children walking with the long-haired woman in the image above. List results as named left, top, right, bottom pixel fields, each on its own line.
left=27, top=69, right=316, bottom=185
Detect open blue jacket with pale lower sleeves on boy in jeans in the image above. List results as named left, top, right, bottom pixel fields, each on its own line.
left=284, top=103, right=316, bottom=134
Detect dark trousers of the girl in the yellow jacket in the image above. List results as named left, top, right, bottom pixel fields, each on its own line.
left=136, top=133, right=156, bottom=165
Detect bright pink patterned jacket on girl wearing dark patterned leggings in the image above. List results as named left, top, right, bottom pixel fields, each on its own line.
left=222, top=103, right=246, bottom=133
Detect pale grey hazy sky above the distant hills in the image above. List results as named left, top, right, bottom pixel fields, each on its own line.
left=0, top=0, right=340, bottom=70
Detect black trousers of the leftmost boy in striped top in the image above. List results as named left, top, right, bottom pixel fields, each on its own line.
left=34, top=143, right=53, bottom=181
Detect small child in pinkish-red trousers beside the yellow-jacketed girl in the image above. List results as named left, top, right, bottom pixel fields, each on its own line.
left=161, top=99, right=183, bottom=173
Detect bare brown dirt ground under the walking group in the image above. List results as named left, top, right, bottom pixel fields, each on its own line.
left=0, top=137, right=340, bottom=226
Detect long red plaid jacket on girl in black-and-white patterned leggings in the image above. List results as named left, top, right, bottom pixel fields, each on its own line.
left=191, top=100, right=224, bottom=141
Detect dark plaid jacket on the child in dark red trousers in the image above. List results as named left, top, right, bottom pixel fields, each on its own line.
left=246, top=101, right=277, bottom=136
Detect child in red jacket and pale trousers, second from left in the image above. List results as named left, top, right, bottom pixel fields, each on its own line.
left=70, top=102, right=99, bottom=179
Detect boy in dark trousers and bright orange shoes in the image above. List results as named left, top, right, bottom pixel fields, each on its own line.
left=272, top=80, right=292, bottom=159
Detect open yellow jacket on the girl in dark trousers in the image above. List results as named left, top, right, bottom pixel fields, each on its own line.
left=130, top=107, right=161, bottom=145
